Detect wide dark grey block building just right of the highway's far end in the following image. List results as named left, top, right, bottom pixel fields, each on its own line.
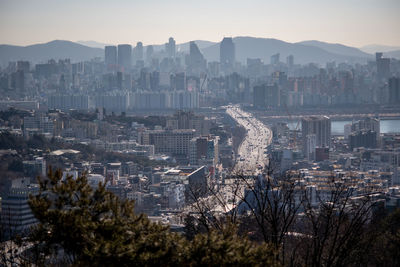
left=253, top=84, right=280, bottom=108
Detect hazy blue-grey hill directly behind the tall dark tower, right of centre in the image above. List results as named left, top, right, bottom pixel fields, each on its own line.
left=202, top=37, right=371, bottom=64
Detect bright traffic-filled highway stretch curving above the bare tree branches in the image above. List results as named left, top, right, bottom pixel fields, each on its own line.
left=226, top=105, right=272, bottom=174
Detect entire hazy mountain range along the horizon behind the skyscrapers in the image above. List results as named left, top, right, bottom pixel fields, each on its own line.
left=0, top=37, right=400, bottom=66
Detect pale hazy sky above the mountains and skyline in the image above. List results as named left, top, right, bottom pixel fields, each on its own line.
left=0, top=0, right=400, bottom=47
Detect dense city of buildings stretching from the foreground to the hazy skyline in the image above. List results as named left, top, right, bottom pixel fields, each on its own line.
left=0, top=37, right=400, bottom=266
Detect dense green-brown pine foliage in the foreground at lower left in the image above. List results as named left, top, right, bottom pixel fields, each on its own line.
left=23, top=170, right=276, bottom=266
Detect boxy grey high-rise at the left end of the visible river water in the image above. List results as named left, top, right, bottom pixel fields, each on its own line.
left=301, top=116, right=331, bottom=156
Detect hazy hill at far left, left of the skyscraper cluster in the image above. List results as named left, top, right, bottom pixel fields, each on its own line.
left=0, top=40, right=104, bottom=65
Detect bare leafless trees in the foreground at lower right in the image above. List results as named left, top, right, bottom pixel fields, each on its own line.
left=185, top=163, right=400, bottom=266
